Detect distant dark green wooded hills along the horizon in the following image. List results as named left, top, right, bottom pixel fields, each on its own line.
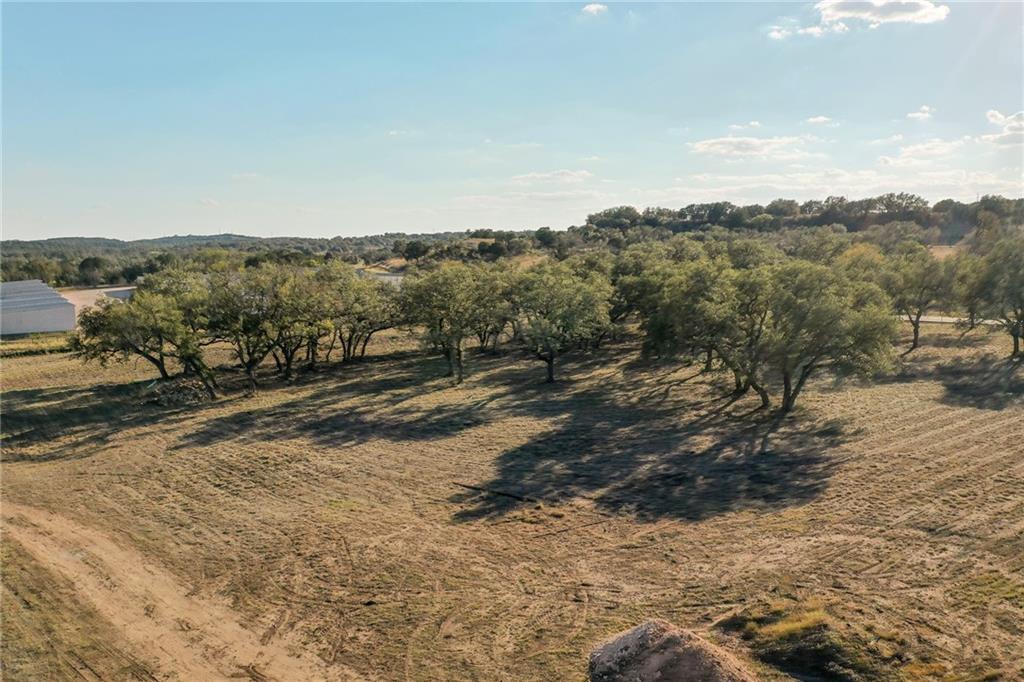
left=6, top=193, right=1024, bottom=287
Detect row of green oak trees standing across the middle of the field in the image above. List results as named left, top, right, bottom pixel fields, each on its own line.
left=72, top=227, right=1024, bottom=412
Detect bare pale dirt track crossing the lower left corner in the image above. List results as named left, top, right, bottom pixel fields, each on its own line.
left=3, top=501, right=361, bottom=681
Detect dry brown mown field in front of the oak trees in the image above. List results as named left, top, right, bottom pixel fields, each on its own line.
left=0, top=326, right=1024, bottom=680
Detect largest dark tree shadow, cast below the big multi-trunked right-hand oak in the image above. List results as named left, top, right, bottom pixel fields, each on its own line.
left=451, top=382, right=843, bottom=521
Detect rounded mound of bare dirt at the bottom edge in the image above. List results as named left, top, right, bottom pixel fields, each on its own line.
left=590, top=621, right=757, bottom=682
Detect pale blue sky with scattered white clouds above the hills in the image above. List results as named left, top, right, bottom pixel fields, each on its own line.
left=2, top=0, right=1024, bottom=239
